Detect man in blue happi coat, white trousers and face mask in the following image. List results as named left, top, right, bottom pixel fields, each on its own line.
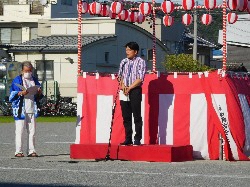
left=9, top=61, right=42, bottom=157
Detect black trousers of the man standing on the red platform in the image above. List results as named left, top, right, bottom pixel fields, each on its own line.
left=120, top=86, right=142, bottom=141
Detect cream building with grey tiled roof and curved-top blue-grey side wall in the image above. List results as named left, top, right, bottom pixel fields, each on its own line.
left=9, top=17, right=168, bottom=97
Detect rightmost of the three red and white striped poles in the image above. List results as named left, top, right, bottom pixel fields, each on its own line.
left=222, top=0, right=227, bottom=70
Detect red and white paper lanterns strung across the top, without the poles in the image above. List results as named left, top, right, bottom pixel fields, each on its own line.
left=78, top=0, right=250, bottom=27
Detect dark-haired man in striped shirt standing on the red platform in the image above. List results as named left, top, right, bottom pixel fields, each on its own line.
left=118, top=42, right=146, bottom=145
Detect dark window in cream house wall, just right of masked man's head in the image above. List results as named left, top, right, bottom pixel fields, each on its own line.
left=36, top=60, right=54, bottom=81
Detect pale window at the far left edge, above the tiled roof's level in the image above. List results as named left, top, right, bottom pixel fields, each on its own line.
left=0, top=28, right=22, bottom=44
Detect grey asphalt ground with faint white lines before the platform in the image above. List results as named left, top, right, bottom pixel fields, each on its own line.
left=0, top=122, right=250, bottom=187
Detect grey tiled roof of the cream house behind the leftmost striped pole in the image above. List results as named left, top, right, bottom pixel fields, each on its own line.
left=9, top=35, right=116, bottom=53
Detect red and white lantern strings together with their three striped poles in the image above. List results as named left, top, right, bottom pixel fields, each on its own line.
left=77, top=0, right=250, bottom=73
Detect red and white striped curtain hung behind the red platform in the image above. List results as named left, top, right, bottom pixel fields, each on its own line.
left=76, top=73, right=250, bottom=160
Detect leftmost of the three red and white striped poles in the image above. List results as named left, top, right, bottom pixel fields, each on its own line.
left=77, top=0, right=82, bottom=75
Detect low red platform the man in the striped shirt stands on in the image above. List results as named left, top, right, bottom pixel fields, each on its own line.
left=70, top=144, right=193, bottom=162
